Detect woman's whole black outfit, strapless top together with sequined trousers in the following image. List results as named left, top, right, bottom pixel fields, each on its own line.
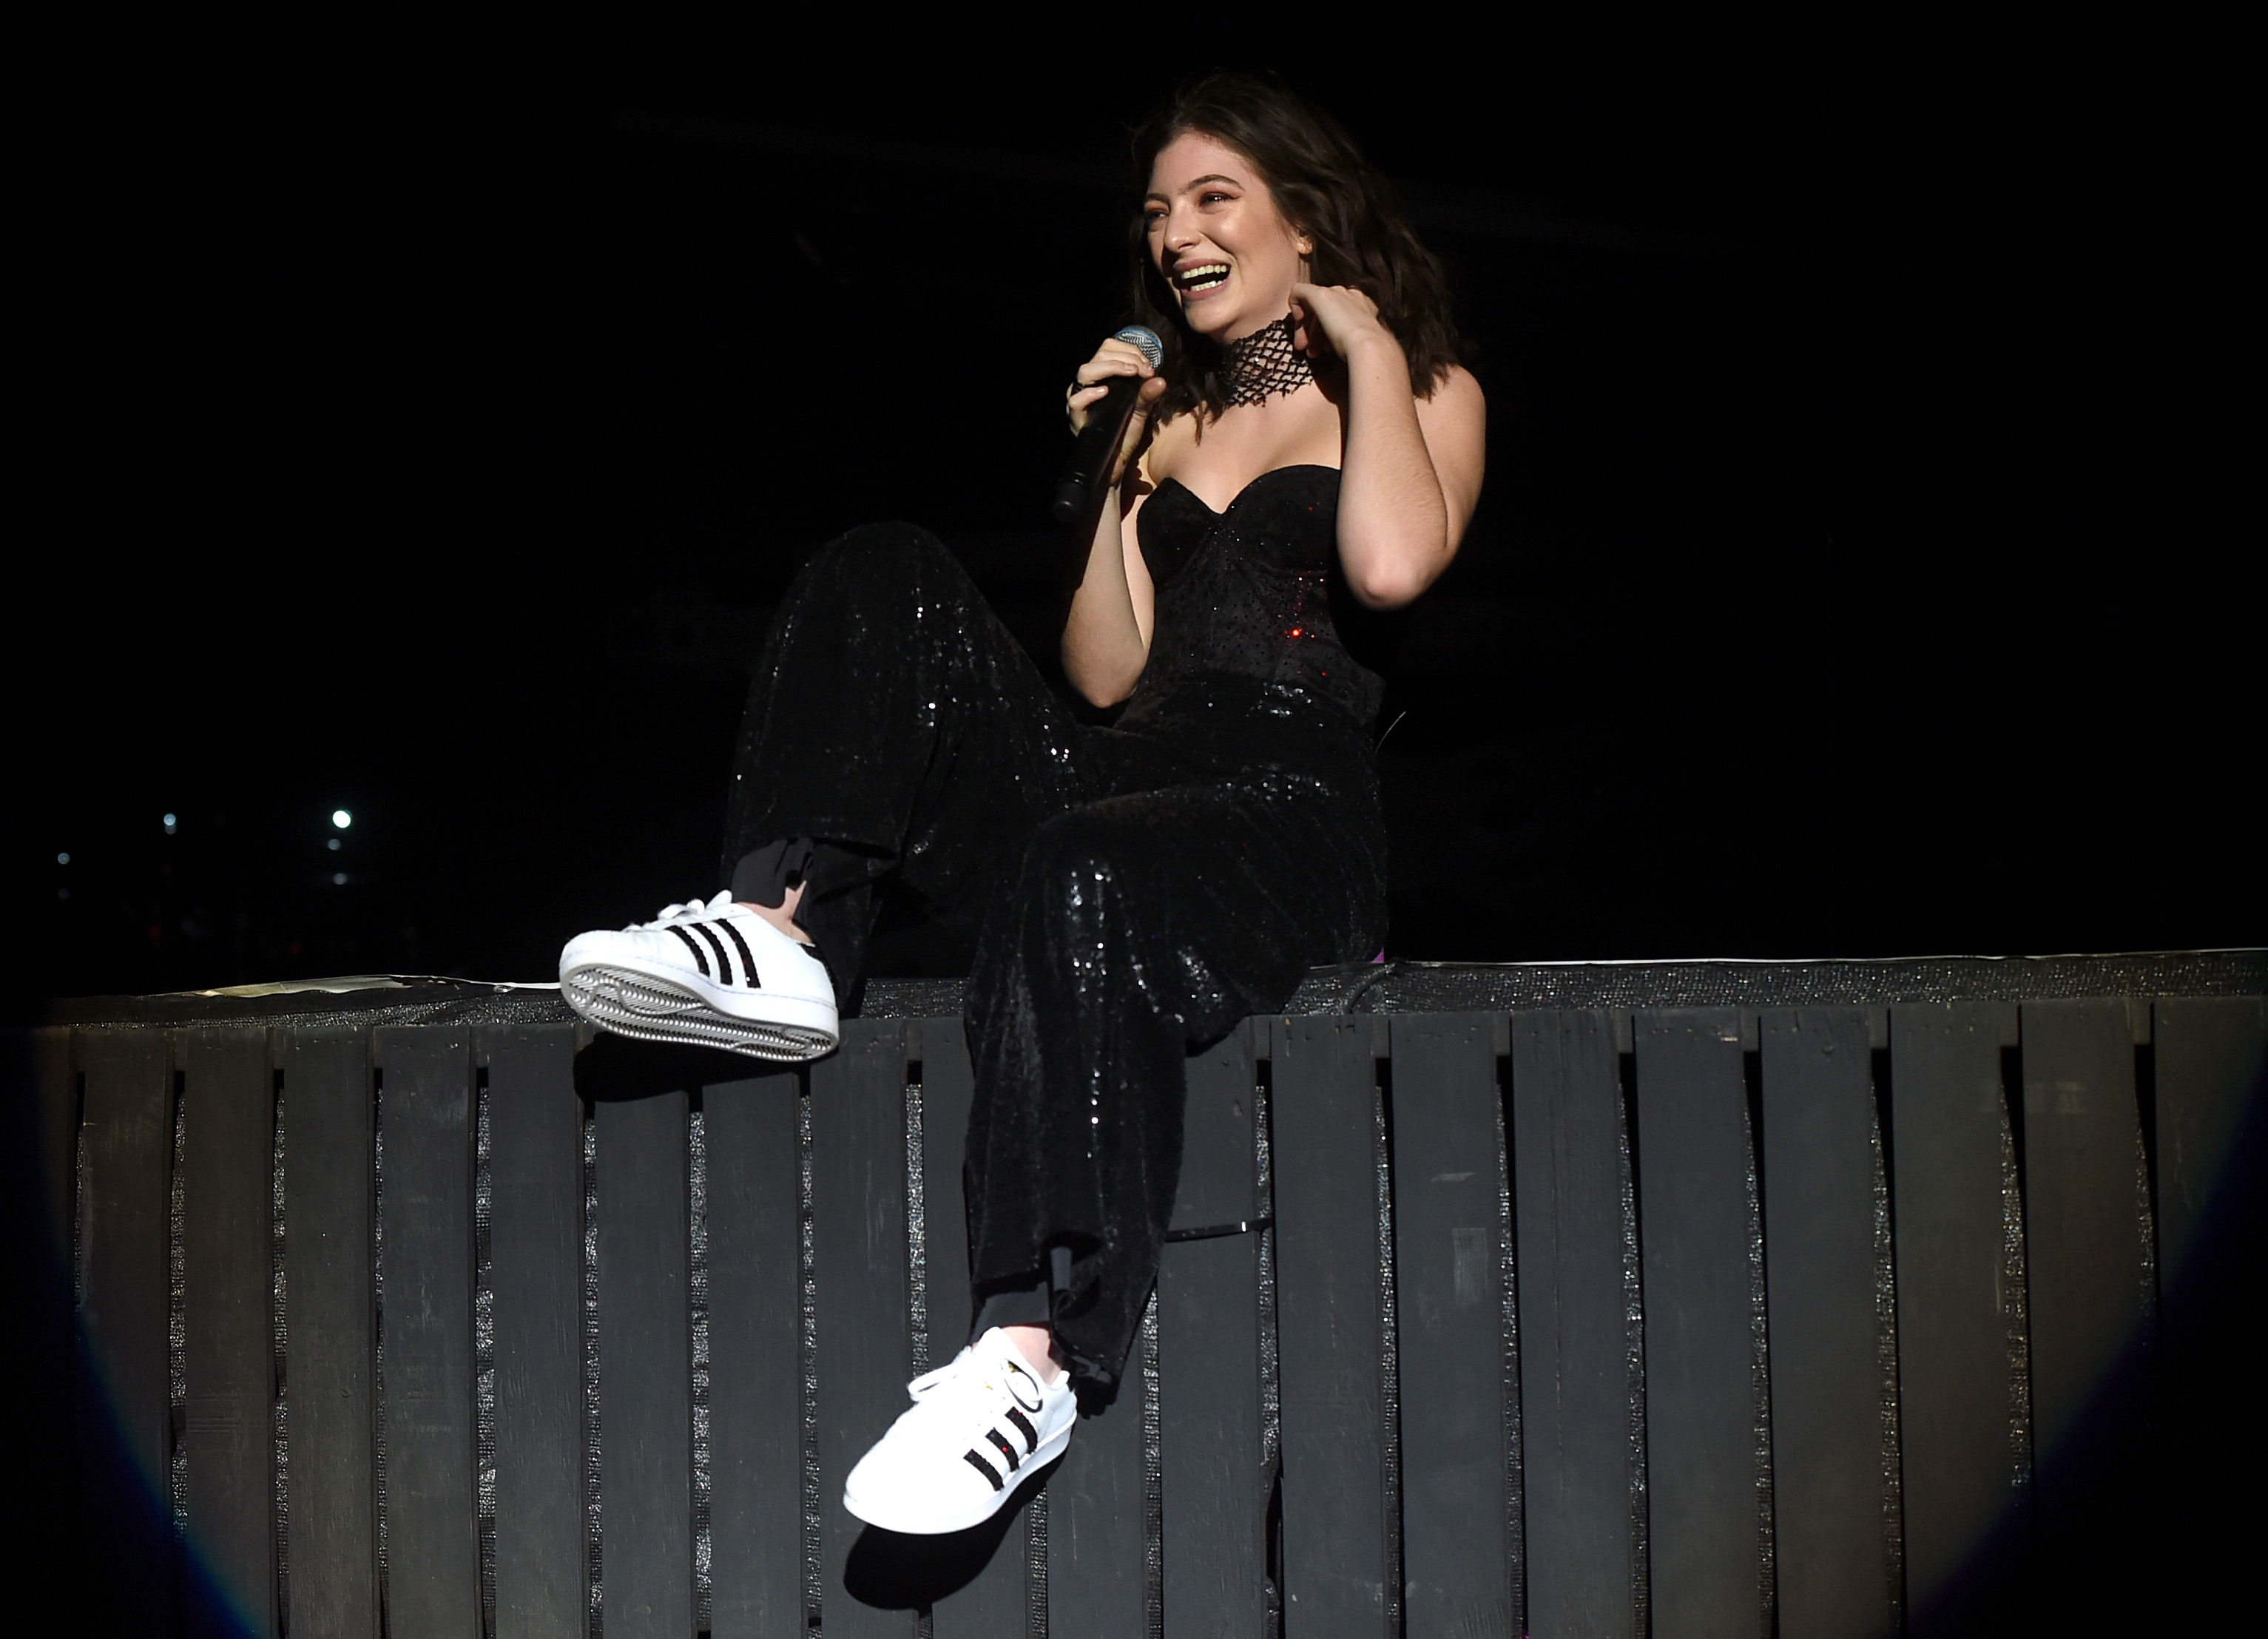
left=726, top=467, right=1386, bottom=1388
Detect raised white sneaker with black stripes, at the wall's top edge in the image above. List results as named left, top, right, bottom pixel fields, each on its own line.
left=560, top=891, right=841, bottom=1058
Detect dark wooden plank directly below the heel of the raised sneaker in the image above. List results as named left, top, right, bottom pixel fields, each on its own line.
left=701, top=1070, right=803, bottom=1639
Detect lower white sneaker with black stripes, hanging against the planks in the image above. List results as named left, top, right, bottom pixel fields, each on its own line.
left=844, top=1326, right=1079, bottom=1537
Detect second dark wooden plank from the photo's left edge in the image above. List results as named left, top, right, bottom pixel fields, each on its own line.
left=75, top=1030, right=175, bottom=1632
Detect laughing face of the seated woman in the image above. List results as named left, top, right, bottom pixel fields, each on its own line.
left=1143, top=132, right=1315, bottom=342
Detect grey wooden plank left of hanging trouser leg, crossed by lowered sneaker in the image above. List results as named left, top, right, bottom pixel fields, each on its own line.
left=919, top=1018, right=1039, bottom=1639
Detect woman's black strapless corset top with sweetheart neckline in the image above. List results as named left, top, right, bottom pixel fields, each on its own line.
left=1130, top=467, right=1386, bottom=732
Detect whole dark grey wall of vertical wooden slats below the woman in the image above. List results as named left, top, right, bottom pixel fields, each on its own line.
left=27, top=979, right=2268, bottom=1639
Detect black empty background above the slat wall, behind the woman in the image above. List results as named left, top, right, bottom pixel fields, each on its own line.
left=0, top=19, right=2268, bottom=1018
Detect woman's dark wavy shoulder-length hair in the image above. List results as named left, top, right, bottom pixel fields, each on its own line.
left=1132, top=72, right=1463, bottom=426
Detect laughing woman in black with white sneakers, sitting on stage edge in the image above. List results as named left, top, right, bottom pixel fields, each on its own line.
left=560, top=75, right=1483, bottom=1532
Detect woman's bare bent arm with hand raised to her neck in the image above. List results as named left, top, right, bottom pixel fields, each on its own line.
left=1291, top=283, right=1488, bottom=609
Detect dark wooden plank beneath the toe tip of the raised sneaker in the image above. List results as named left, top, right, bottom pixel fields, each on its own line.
left=485, top=1024, right=587, bottom=1639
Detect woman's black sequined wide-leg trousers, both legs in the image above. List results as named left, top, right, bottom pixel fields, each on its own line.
left=726, top=524, right=1383, bottom=1383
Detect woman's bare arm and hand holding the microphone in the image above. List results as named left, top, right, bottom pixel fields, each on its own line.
left=1064, top=338, right=1166, bottom=705
